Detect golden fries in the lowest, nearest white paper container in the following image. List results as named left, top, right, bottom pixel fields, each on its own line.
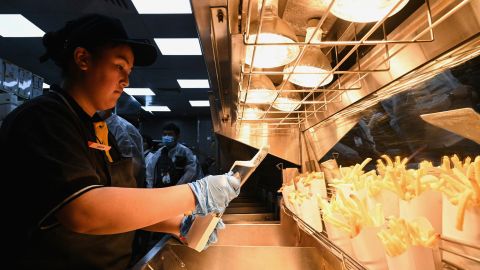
left=377, top=217, right=440, bottom=257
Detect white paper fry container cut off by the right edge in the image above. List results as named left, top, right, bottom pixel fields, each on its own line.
left=442, top=195, right=480, bottom=247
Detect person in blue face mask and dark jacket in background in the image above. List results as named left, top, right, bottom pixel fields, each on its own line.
left=146, top=123, right=203, bottom=187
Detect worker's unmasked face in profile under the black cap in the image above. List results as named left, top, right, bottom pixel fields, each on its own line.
left=77, top=44, right=134, bottom=111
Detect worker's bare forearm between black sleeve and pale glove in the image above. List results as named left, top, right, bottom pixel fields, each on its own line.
left=56, top=185, right=195, bottom=234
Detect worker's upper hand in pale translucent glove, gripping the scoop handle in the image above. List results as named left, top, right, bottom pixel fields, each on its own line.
left=188, top=173, right=240, bottom=216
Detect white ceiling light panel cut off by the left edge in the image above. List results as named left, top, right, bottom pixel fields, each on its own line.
left=0, top=14, right=45, bottom=37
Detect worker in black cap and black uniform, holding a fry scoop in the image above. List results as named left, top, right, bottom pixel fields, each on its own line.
left=0, top=14, right=240, bottom=270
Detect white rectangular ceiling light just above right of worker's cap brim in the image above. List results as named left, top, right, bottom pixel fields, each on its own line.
left=154, top=38, right=202, bottom=55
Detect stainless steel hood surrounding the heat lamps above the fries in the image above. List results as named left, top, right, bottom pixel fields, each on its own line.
left=192, top=0, right=480, bottom=165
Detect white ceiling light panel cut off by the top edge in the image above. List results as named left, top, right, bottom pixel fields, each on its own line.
left=132, top=0, right=192, bottom=14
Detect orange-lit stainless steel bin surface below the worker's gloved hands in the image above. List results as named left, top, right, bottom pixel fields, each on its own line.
left=140, top=208, right=348, bottom=270
